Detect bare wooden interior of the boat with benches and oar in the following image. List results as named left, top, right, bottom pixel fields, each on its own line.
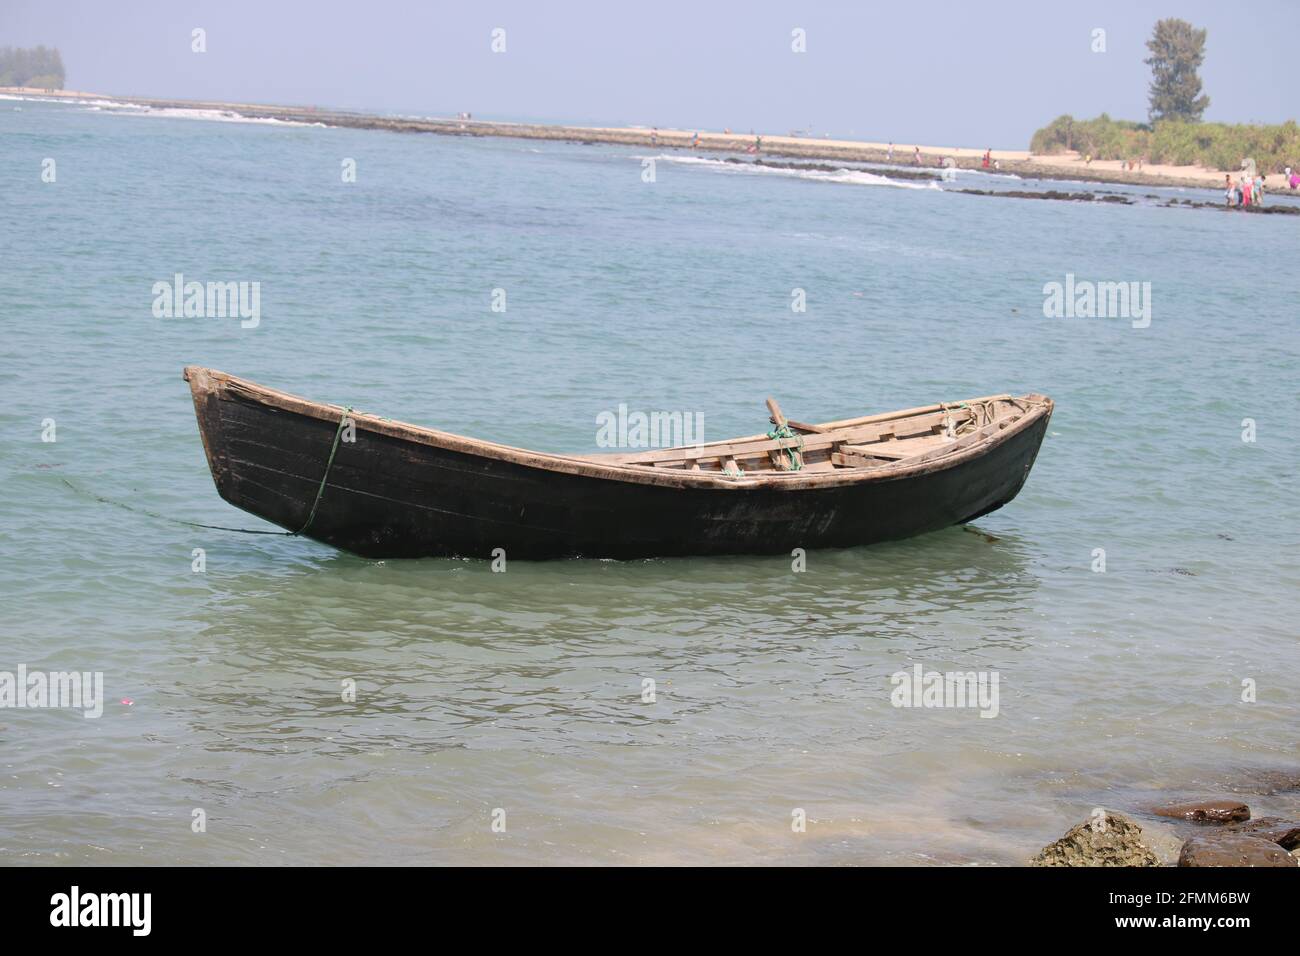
left=585, top=395, right=1045, bottom=477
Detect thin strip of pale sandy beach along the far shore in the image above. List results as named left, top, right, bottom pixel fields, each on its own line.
left=0, top=87, right=1290, bottom=193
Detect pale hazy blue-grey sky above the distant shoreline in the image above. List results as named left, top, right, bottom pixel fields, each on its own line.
left=0, top=0, right=1300, bottom=148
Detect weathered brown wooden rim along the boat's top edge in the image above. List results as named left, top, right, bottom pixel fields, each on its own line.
left=183, top=365, right=1054, bottom=490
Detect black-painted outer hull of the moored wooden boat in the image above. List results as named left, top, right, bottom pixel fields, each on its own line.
left=195, top=369, right=1050, bottom=559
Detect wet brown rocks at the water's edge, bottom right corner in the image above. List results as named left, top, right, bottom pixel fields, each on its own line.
left=1030, top=775, right=1300, bottom=866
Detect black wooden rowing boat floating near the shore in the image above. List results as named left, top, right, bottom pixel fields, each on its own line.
left=185, top=365, right=1053, bottom=558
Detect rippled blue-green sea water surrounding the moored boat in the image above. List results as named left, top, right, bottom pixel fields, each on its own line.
left=0, top=100, right=1300, bottom=864
